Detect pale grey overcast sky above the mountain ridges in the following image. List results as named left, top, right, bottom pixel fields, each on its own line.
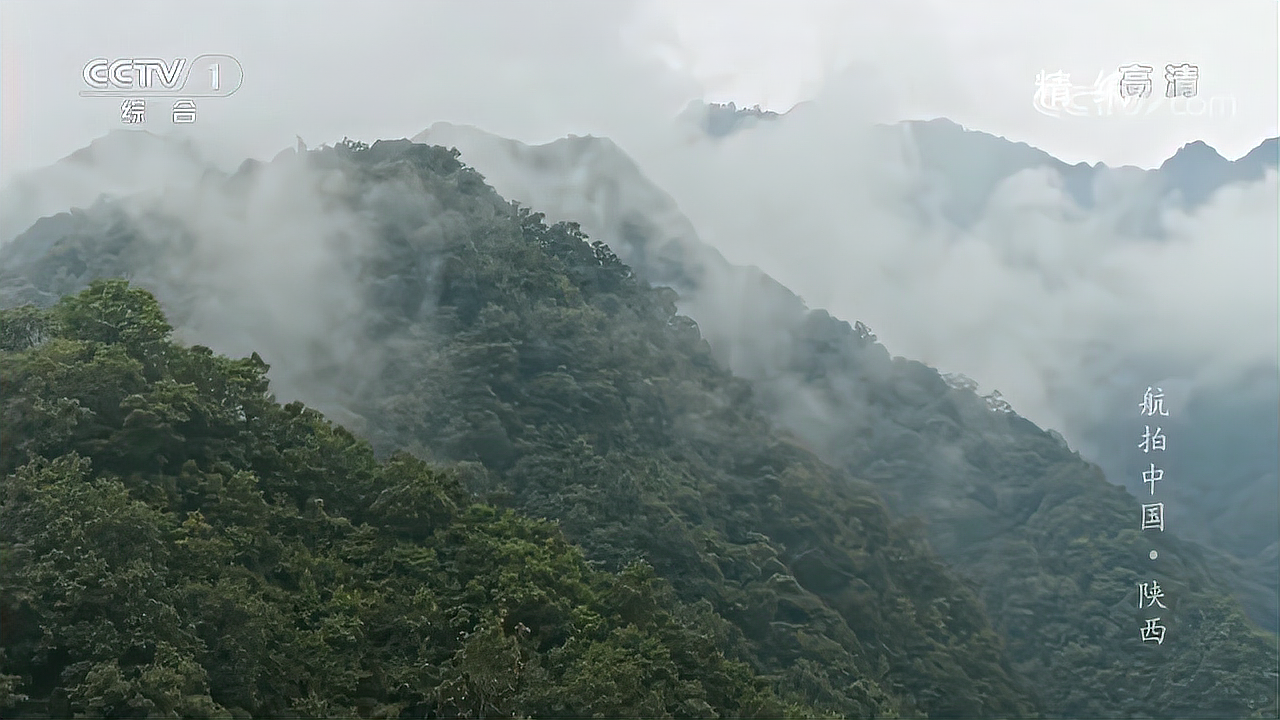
left=0, top=0, right=1280, bottom=176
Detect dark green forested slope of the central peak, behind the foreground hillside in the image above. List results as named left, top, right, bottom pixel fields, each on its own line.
left=340, top=146, right=1034, bottom=716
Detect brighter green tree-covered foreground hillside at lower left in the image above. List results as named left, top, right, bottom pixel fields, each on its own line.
left=0, top=284, right=786, bottom=717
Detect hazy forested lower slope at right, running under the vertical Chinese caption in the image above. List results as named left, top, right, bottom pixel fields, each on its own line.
left=795, top=331, right=1280, bottom=717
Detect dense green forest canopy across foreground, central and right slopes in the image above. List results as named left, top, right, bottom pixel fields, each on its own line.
left=0, top=137, right=1276, bottom=717
